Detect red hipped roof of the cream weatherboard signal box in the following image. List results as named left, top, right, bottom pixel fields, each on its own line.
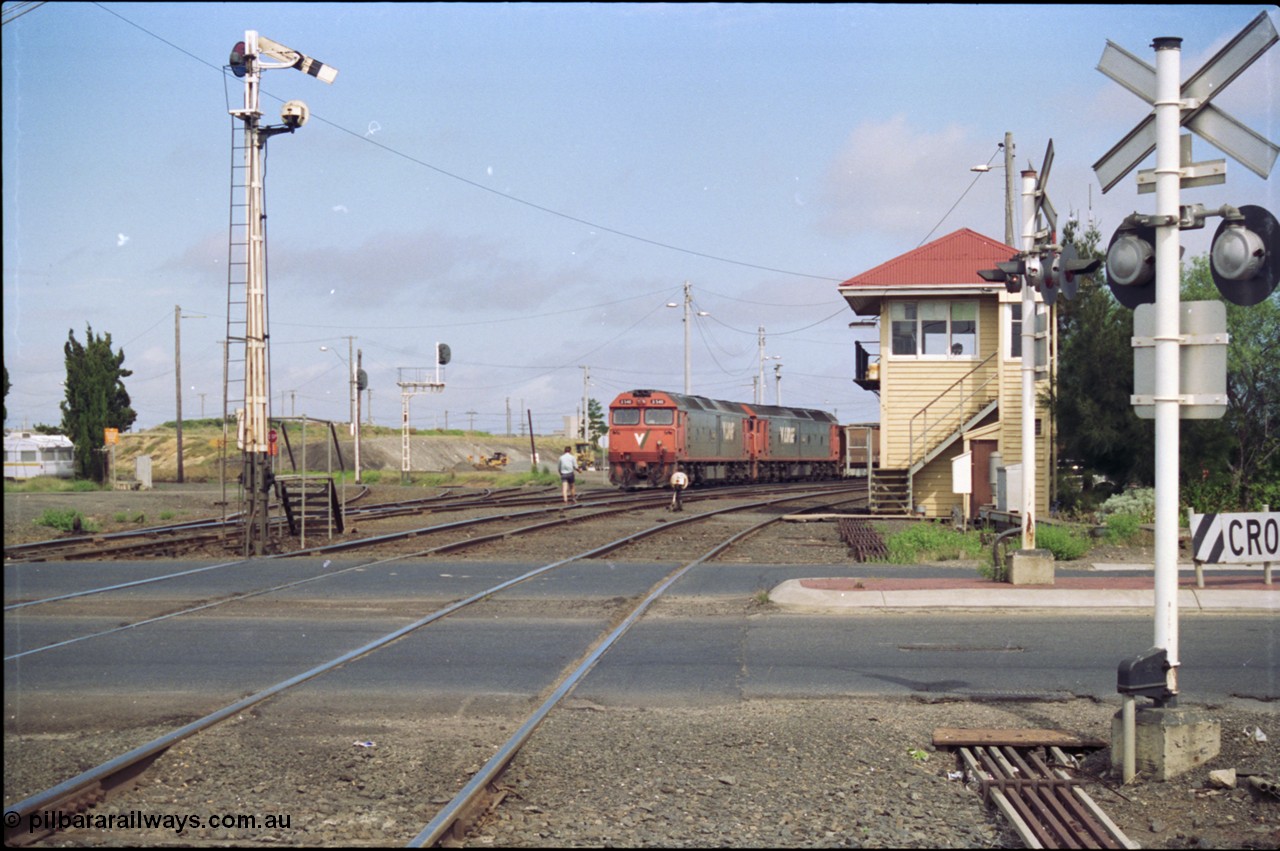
left=840, top=228, right=1016, bottom=289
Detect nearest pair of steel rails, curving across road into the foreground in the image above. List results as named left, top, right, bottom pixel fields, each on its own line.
left=5, top=489, right=861, bottom=843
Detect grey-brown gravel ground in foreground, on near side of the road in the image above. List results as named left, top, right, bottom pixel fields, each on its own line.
left=12, top=697, right=1280, bottom=848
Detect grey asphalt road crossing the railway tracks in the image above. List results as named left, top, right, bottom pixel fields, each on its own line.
left=5, top=559, right=1280, bottom=719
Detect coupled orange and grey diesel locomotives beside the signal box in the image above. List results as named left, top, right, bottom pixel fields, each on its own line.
left=609, top=390, right=842, bottom=489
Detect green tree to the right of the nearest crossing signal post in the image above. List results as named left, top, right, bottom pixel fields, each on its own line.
left=1180, top=255, right=1280, bottom=511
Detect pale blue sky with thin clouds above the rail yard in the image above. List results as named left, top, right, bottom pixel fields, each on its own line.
left=0, top=3, right=1280, bottom=433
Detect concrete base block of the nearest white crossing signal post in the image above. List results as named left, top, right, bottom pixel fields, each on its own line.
left=1111, top=706, right=1222, bottom=781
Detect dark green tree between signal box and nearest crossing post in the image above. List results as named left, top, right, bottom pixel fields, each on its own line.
left=1048, top=220, right=1155, bottom=501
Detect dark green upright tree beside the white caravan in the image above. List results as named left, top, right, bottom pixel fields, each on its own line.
left=60, top=325, right=137, bottom=481
